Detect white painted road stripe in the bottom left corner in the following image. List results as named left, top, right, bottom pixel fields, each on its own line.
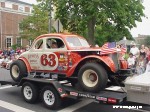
left=0, top=100, right=35, bottom=112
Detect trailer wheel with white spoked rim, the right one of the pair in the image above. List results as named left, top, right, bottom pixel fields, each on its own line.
left=42, top=86, right=61, bottom=110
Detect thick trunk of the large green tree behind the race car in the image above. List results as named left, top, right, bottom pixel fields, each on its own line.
left=88, top=17, right=96, bottom=46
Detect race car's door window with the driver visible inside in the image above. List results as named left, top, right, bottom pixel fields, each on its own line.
left=46, top=38, right=65, bottom=49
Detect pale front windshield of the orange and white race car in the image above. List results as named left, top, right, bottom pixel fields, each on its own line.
left=66, top=37, right=90, bottom=47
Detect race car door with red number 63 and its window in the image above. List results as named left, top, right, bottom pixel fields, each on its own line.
left=40, top=36, right=68, bottom=74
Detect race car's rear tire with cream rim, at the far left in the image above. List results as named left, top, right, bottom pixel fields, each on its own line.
left=10, top=60, right=27, bottom=82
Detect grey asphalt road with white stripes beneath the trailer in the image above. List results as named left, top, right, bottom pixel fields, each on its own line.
left=0, top=68, right=150, bottom=112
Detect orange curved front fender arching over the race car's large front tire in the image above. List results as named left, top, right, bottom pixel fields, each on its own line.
left=67, top=55, right=116, bottom=77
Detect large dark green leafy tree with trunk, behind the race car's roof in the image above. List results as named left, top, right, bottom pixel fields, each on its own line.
left=54, top=0, right=144, bottom=44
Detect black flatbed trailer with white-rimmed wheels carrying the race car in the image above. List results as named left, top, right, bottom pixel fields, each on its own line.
left=0, top=77, right=127, bottom=109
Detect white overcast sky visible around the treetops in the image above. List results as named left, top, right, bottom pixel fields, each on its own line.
left=20, top=0, right=150, bottom=37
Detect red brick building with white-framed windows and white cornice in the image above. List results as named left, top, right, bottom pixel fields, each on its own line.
left=0, top=0, right=33, bottom=49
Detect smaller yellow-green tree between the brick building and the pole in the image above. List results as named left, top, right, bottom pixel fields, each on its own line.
left=19, top=4, right=48, bottom=40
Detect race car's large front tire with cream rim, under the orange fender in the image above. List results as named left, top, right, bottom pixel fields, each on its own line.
left=78, top=63, right=108, bottom=92
